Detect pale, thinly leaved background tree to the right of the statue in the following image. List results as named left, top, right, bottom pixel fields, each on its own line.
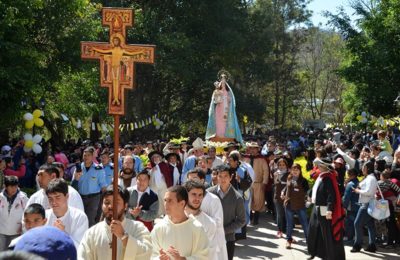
left=297, top=27, right=346, bottom=122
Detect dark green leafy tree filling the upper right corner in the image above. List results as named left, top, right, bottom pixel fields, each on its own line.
left=329, top=0, right=400, bottom=116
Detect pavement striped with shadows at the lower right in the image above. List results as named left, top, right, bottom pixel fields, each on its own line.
left=234, top=212, right=400, bottom=260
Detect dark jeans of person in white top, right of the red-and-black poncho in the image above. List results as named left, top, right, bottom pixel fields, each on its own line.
left=354, top=204, right=376, bottom=246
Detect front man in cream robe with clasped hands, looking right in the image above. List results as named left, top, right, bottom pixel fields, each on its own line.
left=151, top=186, right=209, bottom=260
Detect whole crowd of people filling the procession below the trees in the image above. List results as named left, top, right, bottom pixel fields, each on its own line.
left=0, top=129, right=400, bottom=260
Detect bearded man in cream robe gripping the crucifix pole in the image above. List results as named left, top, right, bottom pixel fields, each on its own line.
left=78, top=185, right=152, bottom=260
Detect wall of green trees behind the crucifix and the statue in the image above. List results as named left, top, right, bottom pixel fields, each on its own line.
left=0, top=0, right=354, bottom=142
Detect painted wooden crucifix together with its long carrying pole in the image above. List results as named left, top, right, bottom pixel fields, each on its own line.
left=81, top=8, right=155, bottom=260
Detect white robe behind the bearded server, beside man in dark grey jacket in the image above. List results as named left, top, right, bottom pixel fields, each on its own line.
left=200, top=191, right=228, bottom=260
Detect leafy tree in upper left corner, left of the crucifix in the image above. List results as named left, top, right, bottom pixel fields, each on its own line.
left=0, top=0, right=101, bottom=143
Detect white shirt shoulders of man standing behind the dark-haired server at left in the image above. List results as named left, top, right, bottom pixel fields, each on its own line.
left=25, top=185, right=85, bottom=212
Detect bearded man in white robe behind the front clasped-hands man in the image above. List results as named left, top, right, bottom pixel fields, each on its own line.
left=185, top=180, right=219, bottom=260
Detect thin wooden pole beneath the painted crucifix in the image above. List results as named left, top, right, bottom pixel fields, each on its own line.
left=111, top=115, right=119, bottom=260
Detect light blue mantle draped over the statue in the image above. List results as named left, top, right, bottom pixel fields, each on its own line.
left=206, top=83, right=243, bottom=143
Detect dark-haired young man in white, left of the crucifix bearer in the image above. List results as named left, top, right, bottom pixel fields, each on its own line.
left=46, top=179, right=89, bottom=248
